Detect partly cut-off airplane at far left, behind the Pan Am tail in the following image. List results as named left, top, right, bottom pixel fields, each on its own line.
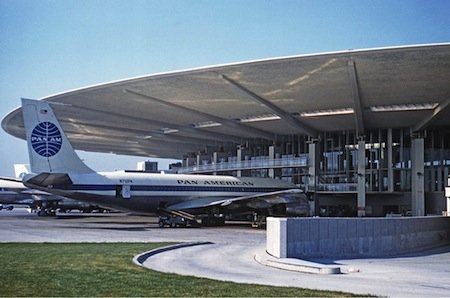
left=0, top=165, right=104, bottom=216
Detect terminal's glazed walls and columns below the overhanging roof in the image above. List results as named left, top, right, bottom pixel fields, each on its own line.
left=178, top=128, right=450, bottom=216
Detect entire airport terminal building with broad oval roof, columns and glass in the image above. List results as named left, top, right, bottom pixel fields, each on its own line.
left=2, top=44, right=450, bottom=216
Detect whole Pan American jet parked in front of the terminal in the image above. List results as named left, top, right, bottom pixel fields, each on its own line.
left=22, top=99, right=309, bottom=224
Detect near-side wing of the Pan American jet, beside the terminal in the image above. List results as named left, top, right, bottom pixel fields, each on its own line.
left=168, top=189, right=309, bottom=214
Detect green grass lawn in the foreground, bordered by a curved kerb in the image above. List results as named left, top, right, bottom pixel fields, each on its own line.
left=0, top=243, right=358, bottom=297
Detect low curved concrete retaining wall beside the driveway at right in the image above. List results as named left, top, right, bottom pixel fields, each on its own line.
left=266, top=217, right=450, bottom=258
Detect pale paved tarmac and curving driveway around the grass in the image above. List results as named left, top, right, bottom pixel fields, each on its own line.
left=0, top=210, right=450, bottom=297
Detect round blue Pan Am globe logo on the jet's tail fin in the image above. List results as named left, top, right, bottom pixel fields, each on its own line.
left=31, top=121, right=62, bottom=157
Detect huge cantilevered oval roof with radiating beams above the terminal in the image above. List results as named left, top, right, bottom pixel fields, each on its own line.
left=2, top=43, right=450, bottom=158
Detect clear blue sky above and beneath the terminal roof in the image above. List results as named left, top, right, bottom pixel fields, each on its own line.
left=0, top=0, right=450, bottom=176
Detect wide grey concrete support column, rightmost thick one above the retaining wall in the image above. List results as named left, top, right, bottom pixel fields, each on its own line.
left=411, top=138, right=425, bottom=216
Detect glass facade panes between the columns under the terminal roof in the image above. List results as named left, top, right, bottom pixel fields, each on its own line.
left=180, top=129, right=450, bottom=215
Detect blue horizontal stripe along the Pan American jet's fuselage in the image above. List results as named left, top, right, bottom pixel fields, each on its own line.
left=68, top=184, right=284, bottom=192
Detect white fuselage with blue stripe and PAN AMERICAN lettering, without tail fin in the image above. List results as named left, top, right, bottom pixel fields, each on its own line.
left=31, top=171, right=295, bottom=213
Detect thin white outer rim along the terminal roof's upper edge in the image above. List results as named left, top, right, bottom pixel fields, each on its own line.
left=39, top=42, right=450, bottom=100
